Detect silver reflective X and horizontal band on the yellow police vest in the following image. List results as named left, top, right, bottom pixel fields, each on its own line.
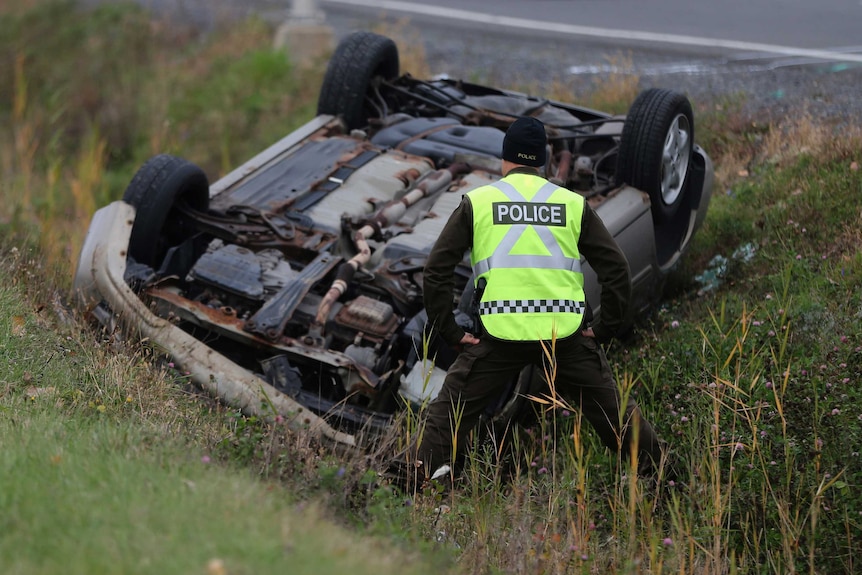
left=473, top=181, right=581, bottom=277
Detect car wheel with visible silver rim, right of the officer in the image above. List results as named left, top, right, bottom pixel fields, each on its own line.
left=616, top=88, right=694, bottom=225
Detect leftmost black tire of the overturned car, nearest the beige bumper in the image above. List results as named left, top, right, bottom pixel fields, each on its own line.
left=123, top=154, right=209, bottom=268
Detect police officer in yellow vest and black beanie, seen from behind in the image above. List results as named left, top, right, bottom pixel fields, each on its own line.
left=417, top=118, right=661, bottom=477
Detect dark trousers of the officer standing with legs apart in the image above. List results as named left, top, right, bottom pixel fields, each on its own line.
left=417, top=333, right=661, bottom=475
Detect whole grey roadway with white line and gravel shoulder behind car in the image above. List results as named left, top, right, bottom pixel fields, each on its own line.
left=86, top=0, right=862, bottom=123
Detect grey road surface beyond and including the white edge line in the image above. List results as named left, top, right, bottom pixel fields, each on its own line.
left=319, top=0, right=862, bottom=62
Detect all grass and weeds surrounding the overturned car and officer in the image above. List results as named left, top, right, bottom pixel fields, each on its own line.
left=0, top=0, right=862, bottom=574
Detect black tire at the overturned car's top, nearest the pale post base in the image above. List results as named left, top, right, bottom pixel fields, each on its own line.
left=317, top=32, right=400, bottom=130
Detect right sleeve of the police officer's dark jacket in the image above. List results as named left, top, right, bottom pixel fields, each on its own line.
left=578, top=206, right=631, bottom=342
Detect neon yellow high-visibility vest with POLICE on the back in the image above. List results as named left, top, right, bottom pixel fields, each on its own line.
left=467, top=174, right=586, bottom=341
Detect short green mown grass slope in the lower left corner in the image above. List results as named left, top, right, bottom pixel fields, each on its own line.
left=0, top=272, right=446, bottom=574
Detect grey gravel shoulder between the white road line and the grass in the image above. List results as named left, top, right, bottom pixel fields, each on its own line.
left=81, top=0, right=862, bottom=124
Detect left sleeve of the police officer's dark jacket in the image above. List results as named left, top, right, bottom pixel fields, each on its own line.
left=423, top=197, right=473, bottom=346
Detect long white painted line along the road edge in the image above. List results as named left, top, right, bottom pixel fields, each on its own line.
left=323, top=0, right=862, bottom=62
